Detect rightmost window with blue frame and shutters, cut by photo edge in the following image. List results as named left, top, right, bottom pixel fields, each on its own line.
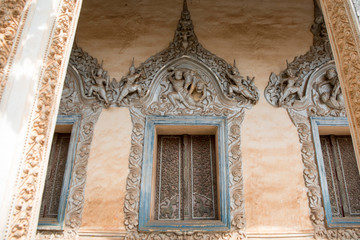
left=311, top=117, right=360, bottom=229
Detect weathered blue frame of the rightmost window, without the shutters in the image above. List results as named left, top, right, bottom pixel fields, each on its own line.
left=311, top=117, right=360, bottom=228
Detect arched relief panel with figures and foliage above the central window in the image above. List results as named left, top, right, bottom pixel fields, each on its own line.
left=139, top=61, right=255, bottom=115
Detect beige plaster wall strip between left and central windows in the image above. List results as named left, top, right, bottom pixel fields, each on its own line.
left=82, top=108, right=132, bottom=231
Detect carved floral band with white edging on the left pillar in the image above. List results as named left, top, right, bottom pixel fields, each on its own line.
left=5, top=0, right=81, bottom=239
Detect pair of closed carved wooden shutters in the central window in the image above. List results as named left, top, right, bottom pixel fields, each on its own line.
left=154, top=135, right=218, bottom=220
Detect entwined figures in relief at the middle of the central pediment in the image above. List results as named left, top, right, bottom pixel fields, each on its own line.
left=167, top=69, right=206, bottom=109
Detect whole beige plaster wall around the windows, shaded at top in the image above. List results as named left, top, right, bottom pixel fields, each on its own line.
left=77, top=0, right=313, bottom=236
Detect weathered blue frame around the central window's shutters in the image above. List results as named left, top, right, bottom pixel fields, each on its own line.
left=139, top=116, right=231, bottom=231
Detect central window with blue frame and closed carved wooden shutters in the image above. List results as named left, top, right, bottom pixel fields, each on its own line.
left=139, top=116, right=231, bottom=232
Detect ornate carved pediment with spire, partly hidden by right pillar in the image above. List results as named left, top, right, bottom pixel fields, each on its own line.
left=265, top=3, right=345, bottom=116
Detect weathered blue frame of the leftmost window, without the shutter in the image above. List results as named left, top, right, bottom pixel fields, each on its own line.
left=38, top=115, right=81, bottom=230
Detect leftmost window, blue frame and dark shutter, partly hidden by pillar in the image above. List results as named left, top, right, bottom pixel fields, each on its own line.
left=38, top=115, right=81, bottom=230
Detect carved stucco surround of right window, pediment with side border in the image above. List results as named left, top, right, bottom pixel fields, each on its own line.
left=265, top=3, right=360, bottom=239
